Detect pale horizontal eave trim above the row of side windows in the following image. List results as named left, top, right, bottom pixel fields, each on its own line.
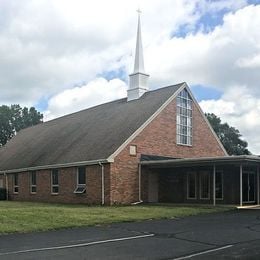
left=0, top=159, right=114, bottom=174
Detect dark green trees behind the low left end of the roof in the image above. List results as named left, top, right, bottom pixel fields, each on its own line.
left=0, top=105, right=43, bottom=146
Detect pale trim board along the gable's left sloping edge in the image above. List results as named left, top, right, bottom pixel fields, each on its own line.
left=108, top=83, right=187, bottom=160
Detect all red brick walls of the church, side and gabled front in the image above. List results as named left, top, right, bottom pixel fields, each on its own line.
left=1, top=92, right=225, bottom=204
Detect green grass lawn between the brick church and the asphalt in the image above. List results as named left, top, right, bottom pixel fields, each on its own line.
left=0, top=201, right=233, bottom=234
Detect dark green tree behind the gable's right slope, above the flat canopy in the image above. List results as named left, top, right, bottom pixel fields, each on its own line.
left=205, top=113, right=251, bottom=155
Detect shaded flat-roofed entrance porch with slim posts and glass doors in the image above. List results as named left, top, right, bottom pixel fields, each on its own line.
left=140, top=156, right=260, bottom=206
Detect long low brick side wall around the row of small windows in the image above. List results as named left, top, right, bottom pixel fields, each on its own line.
left=8, top=164, right=110, bottom=204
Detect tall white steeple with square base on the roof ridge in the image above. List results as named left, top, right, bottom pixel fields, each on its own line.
left=127, top=10, right=149, bottom=101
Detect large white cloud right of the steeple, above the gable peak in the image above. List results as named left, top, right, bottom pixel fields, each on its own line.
left=146, top=5, right=260, bottom=91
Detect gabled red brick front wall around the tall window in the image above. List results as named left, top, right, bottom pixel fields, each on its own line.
left=111, top=97, right=225, bottom=204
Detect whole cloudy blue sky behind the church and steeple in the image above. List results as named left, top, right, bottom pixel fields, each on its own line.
left=0, top=0, right=260, bottom=154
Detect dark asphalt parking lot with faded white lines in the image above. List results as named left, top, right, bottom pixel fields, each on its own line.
left=0, top=209, right=260, bottom=259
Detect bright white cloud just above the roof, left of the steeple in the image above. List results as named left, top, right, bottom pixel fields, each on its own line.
left=44, top=78, right=127, bottom=121
